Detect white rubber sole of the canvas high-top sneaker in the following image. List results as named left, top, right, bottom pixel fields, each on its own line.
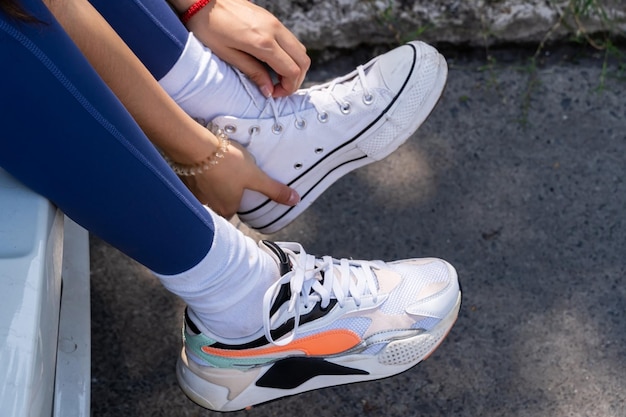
left=237, top=48, right=448, bottom=234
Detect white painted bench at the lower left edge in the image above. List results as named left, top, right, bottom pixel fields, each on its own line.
left=0, top=169, right=91, bottom=417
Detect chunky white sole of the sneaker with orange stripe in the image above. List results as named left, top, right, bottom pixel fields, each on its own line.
left=176, top=292, right=461, bottom=411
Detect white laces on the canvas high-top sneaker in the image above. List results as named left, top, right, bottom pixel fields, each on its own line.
left=236, top=61, right=375, bottom=133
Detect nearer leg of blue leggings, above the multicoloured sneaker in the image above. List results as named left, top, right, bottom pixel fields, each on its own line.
left=0, top=0, right=214, bottom=274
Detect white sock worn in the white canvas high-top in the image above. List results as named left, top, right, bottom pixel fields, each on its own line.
left=159, top=33, right=265, bottom=122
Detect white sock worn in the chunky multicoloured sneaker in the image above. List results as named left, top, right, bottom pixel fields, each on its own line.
left=155, top=211, right=280, bottom=339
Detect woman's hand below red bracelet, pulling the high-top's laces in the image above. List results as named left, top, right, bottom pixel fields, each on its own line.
left=177, top=0, right=311, bottom=97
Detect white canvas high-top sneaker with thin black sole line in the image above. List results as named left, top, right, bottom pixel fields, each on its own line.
left=211, top=41, right=448, bottom=233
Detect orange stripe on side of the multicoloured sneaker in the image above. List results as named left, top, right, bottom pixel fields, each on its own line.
left=202, top=330, right=361, bottom=358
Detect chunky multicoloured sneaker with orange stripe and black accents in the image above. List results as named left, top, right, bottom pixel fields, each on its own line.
left=177, top=241, right=461, bottom=411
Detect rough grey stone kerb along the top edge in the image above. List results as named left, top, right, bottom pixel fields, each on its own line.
left=256, top=0, right=626, bottom=50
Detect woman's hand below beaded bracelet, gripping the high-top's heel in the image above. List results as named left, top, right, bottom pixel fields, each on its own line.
left=181, top=142, right=300, bottom=218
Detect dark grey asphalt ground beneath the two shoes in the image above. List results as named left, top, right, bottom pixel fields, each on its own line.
left=91, top=43, right=626, bottom=417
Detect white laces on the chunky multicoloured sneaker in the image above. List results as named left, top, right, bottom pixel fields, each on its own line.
left=263, top=243, right=378, bottom=346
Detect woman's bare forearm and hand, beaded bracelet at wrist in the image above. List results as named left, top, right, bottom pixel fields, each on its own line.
left=44, top=0, right=299, bottom=216
